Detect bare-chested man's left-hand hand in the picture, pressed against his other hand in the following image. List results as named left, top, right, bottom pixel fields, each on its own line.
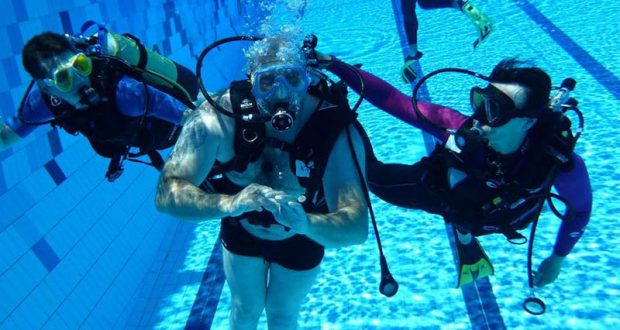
left=225, top=183, right=277, bottom=217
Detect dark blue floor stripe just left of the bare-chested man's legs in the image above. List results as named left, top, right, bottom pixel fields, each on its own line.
left=185, top=238, right=225, bottom=329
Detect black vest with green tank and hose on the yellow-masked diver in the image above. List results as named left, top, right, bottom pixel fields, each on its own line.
left=19, top=21, right=198, bottom=181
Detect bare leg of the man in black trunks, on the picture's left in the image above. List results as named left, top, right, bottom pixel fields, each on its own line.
left=223, top=248, right=269, bottom=330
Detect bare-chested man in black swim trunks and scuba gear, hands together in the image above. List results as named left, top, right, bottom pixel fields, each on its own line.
left=156, top=34, right=368, bottom=329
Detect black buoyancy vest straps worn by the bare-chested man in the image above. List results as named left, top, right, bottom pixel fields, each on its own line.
left=202, top=80, right=357, bottom=226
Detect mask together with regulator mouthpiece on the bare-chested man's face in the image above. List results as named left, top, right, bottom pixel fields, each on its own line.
left=251, top=64, right=310, bottom=131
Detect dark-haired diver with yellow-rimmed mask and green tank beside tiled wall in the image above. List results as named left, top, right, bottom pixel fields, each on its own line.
left=0, top=21, right=198, bottom=182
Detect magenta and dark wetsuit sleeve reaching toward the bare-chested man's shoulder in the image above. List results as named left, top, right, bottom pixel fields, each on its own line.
left=327, top=61, right=467, bottom=141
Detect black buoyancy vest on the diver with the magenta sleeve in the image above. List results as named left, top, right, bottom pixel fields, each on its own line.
left=428, top=111, right=575, bottom=239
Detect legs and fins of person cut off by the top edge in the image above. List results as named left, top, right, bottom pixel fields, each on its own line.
left=400, top=0, right=493, bottom=83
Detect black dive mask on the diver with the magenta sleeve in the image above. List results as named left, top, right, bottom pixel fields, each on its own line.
left=469, top=85, right=518, bottom=127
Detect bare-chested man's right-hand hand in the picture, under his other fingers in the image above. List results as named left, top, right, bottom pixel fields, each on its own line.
left=265, top=191, right=309, bottom=235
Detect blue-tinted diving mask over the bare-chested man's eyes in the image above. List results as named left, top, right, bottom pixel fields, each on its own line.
left=252, top=64, right=310, bottom=99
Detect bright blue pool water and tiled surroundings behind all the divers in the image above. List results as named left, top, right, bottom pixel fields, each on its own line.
left=0, top=0, right=620, bottom=329
